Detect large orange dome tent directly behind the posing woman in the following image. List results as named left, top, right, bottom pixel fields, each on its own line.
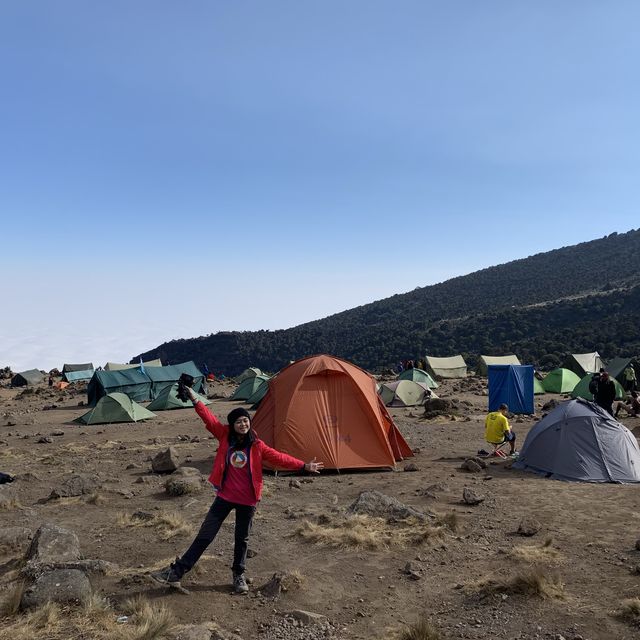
left=252, top=355, right=413, bottom=469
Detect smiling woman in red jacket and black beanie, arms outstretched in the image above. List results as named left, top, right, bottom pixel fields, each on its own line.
left=150, top=388, right=324, bottom=594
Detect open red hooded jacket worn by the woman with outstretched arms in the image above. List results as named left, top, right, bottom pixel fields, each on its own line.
left=194, top=402, right=305, bottom=500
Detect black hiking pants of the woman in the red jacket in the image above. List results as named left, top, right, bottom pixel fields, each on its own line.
left=173, top=498, right=256, bottom=577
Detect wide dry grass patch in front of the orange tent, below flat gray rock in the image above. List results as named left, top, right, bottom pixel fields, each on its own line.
left=293, top=515, right=443, bottom=551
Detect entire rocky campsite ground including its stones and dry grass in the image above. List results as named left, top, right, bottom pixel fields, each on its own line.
left=0, top=378, right=640, bottom=640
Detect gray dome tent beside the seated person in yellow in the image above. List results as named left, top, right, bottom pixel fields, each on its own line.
left=513, top=399, right=640, bottom=483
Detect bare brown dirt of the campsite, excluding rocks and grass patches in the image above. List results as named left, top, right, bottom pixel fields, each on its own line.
left=0, top=379, right=640, bottom=640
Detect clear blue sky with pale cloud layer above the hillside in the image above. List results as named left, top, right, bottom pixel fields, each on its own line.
left=0, top=0, right=640, bottom=371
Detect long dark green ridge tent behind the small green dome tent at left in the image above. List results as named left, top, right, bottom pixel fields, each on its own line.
left=87, top=362, right=204, bottom=406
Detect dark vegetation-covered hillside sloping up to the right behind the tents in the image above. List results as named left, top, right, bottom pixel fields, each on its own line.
left=133, top=230, right=640, bottom=375
